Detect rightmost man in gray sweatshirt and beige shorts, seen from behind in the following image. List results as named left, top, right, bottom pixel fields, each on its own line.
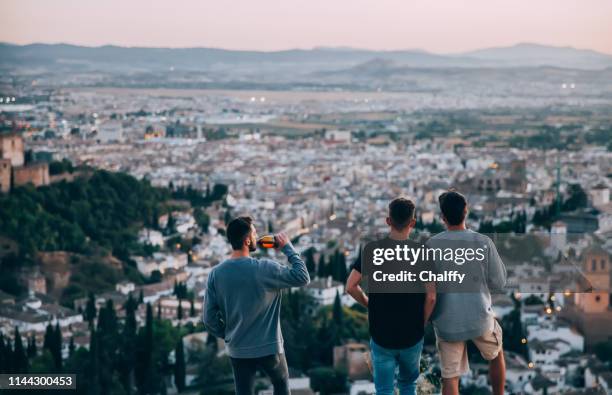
left=427, top=191, right=506, bottom=395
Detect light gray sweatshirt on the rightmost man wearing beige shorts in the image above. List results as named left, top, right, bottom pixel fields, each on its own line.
left=427, top=230, right=506, bottom=341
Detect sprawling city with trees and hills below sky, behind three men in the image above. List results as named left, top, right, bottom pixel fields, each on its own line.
left=0, top=3, right=612, bottom=395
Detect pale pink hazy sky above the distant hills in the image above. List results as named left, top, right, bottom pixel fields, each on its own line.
left=0, top=0, right=612, bottom=54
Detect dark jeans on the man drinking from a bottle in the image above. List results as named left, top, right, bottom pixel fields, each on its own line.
left=231, top=354, right=289, bottom=395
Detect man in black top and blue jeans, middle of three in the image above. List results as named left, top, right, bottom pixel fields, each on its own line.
left=346, top=197, right=436, bottom=395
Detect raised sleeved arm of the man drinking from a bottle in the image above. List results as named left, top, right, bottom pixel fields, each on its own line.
left=261, top=233, right=310, bottom=289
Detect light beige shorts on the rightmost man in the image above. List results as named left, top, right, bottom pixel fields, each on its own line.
left=436, top=320, right=502, bottom=379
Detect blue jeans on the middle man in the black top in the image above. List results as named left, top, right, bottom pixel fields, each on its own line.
left=370, top=339, right=423, bottom=395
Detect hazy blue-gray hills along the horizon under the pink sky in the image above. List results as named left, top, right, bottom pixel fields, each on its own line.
left=0, top=43, right=612, bottom=72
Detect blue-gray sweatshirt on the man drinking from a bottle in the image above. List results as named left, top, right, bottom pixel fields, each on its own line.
left=204, top=243, right=310, bottom=358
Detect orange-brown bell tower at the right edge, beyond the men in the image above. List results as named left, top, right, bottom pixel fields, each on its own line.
left=576, top=246, right=610, bottom=313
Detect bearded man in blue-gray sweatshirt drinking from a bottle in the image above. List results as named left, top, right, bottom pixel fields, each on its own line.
left=204, top=217, right=310, bottom=395
